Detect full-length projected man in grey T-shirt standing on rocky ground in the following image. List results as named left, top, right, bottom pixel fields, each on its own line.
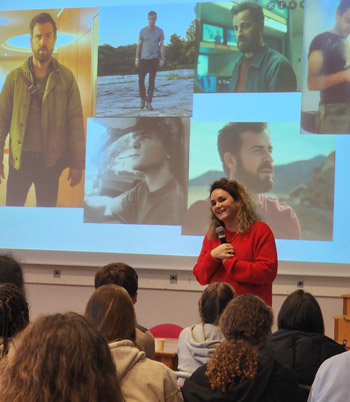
left=135, top=11, right=165, bottom=110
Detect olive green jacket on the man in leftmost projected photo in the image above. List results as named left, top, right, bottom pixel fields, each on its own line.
left=0, top=59, right=85, bottom=169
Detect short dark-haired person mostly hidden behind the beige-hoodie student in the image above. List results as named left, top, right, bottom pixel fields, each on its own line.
left=95, top=262, right=155, bottom=359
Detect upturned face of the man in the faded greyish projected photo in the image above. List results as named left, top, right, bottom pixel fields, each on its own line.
left=131, top=133, right=167, bottom=173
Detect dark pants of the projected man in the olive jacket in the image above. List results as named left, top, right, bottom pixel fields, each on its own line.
left=6, top=151, right=64, bottom=207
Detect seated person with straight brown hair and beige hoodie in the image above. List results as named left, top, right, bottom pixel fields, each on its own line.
left=85, top=285, right=183, bottom=402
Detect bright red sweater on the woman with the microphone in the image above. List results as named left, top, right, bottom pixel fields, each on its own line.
left=193, top=221, right=278, bottom=306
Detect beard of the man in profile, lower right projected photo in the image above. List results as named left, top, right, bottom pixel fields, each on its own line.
left=234, top=160, right=274, bottom=193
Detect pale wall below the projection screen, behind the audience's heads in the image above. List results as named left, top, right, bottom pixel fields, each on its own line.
left=23, top=264, right=350, bottom=338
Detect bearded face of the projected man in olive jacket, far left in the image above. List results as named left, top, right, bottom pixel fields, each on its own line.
left=30, top=22, right=56, bottom=63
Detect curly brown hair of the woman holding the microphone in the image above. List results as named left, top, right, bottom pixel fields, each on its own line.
left=208, top=177, right=259, bottom=239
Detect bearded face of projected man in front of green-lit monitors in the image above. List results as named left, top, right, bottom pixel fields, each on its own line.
left=233, top=10, right=262, bottom=54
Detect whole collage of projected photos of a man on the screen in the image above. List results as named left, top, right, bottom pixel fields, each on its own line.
left=0, top=0, right=344, bottom=251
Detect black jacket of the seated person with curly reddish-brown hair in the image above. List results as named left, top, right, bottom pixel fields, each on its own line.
left=182, top=351, right=302, bottom=402
